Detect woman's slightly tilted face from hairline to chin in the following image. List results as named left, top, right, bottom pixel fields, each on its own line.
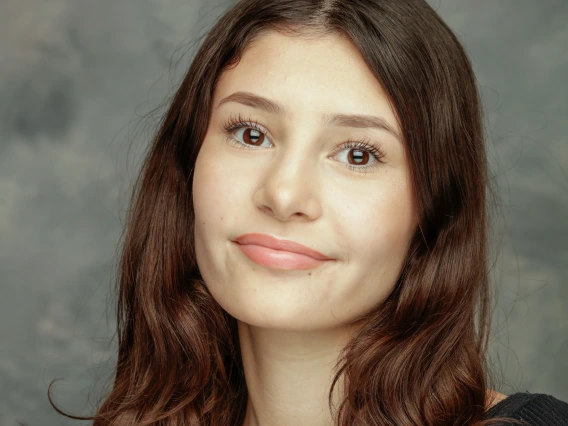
left=193, top=32, right=417, bottom=331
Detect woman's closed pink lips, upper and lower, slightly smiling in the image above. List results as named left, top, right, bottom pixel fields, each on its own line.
left=234, top=234, right=333, bottom=269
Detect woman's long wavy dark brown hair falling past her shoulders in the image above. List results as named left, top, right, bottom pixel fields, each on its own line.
left=48, top=0, right=519, bottom=426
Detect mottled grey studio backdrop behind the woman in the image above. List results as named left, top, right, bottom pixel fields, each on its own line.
left=0, top=0, right=568, bottom=426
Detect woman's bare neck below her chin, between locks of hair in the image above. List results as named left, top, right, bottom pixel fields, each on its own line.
left=238, top=321, right=353, bottom=426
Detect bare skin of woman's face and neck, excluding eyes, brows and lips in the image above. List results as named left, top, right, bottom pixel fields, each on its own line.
left=193, top=28, right=502, bottom=426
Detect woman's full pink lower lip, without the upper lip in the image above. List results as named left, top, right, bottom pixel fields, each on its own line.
left=236, top=243, right=326, bottom=269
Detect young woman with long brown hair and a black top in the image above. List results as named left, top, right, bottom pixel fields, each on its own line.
left=48, top=0, right=568, bottom=426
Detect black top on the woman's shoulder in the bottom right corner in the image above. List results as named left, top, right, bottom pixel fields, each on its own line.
left=483, top=391, right=568, bottom=426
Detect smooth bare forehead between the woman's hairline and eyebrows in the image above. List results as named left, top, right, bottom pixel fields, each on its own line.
left=213, top=31, right=398, bottom=129
